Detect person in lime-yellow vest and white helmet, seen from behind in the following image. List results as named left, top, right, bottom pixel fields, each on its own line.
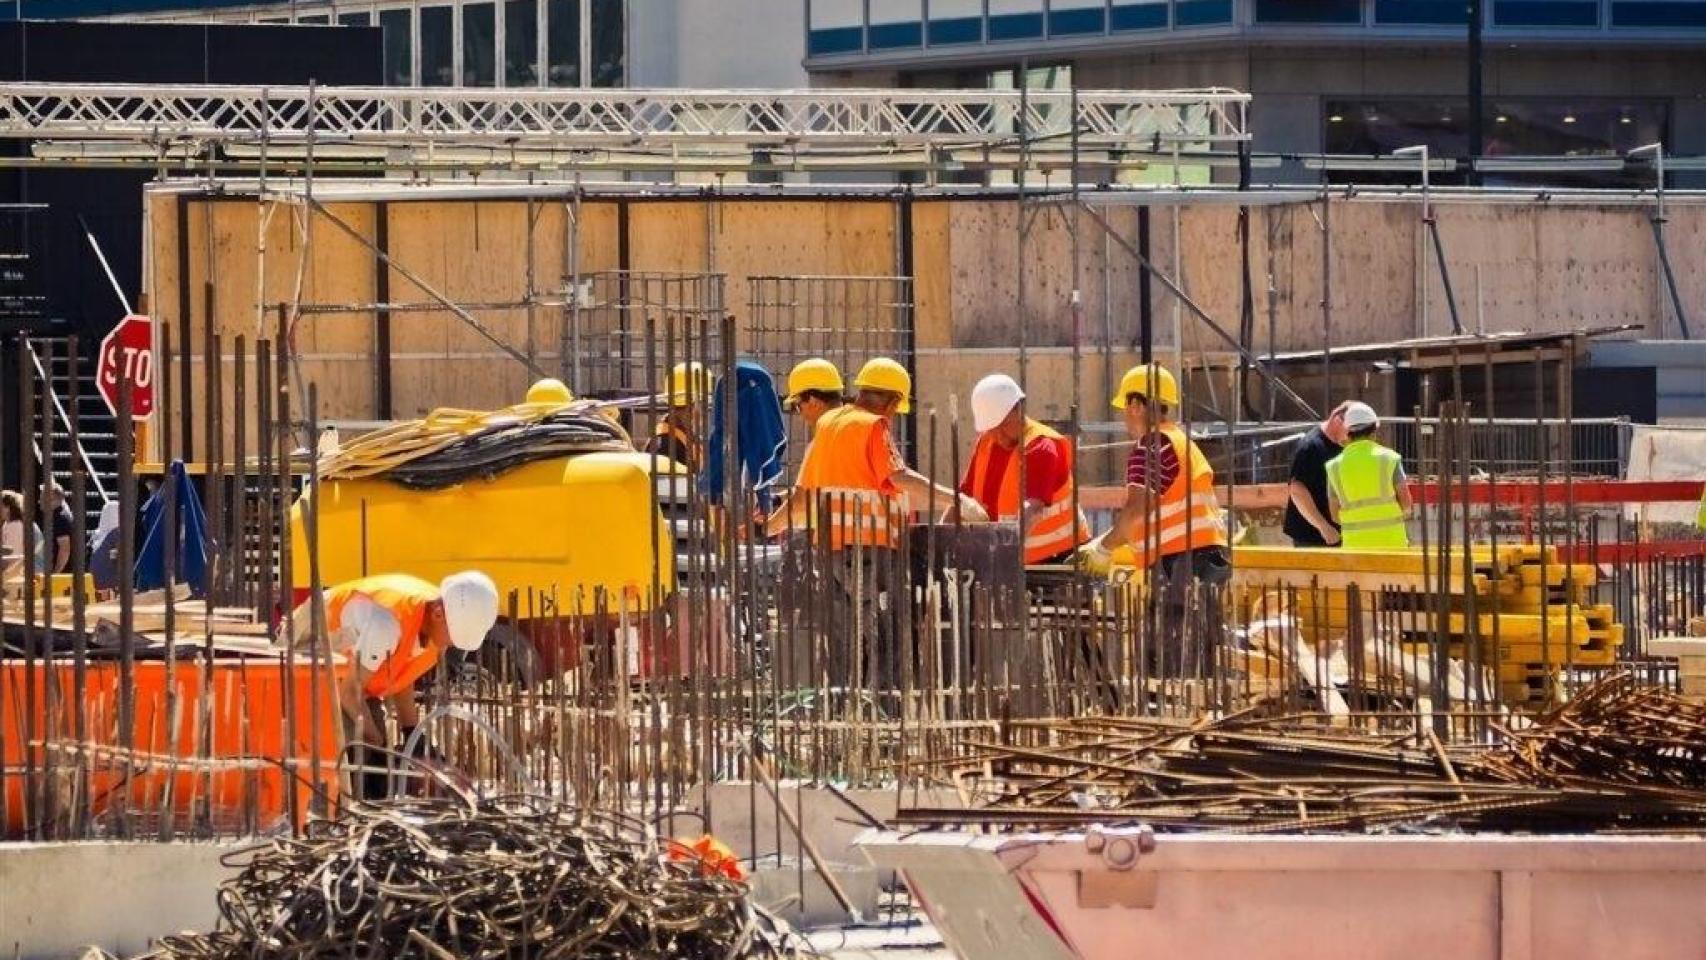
left=1327, top=402, right=1411, bottom=551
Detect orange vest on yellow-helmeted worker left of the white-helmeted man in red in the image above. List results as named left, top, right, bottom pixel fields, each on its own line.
left=798, top=404, right=906, bottom=551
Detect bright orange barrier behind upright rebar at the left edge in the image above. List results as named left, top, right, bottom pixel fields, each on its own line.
left=0, top=660, right=349, bottom=837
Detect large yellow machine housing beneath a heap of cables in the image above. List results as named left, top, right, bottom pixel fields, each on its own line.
left=290, top=452, right=676, bottom=617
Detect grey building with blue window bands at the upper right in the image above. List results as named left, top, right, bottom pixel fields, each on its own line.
left=802, top=0, right=1706, bottom=186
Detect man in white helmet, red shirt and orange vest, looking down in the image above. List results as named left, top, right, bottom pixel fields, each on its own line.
left=960, top=373, right=1090, bottom=564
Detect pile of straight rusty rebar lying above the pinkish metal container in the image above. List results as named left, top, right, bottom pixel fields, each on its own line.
left=897, top=675, right=1706, bottom=834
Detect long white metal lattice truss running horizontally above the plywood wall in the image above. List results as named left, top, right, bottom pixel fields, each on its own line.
left=0, top=84, right=1249, bottom=152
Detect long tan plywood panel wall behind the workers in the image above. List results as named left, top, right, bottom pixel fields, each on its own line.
left=148, top=191, right=1706, bottom=460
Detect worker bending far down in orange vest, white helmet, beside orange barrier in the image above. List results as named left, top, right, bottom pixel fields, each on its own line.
left=292, top=570, right=498, bottom=796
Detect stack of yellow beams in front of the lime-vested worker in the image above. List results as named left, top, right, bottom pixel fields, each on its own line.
left=1233, top=544, right=1624, bottom=708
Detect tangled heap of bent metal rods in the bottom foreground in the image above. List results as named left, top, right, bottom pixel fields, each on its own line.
left=133, top=796, right=812, bottom=960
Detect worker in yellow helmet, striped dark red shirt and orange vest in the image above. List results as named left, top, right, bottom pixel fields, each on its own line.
left=1080, top=363, right=1232, bottom=672
